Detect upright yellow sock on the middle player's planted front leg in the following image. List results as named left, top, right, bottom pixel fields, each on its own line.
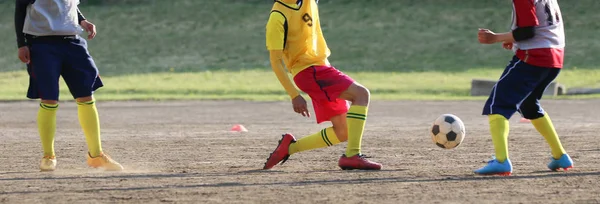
left=346, top=105, right=368, bottom=157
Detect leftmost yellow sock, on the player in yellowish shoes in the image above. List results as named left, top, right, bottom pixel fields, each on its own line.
left=37, top=103, right=58, bottom=157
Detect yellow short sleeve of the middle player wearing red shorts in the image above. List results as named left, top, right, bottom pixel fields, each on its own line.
left=266, top=11, right=287, bottom=50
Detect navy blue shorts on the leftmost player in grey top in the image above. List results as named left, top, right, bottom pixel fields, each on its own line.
left=27, top=36, right=103, bottom=100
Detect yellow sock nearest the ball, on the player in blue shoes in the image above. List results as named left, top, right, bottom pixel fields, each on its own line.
left=489, top=114, right=509, bottom=162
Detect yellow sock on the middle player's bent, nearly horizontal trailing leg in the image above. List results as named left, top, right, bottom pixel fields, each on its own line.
left=289, top=127, right=340, bottom=154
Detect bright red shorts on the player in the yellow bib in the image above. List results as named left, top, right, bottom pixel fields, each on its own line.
left=294, top=66, right=354, bottom=123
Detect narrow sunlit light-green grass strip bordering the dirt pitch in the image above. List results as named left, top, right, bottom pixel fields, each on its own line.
left=0, top=69, right=600, bottom=101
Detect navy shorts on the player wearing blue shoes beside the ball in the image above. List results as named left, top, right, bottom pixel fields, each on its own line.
left=483, top=56, right=561, bottom=119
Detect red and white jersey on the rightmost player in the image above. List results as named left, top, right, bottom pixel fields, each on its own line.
left=512, top=0, right=565, bottom=68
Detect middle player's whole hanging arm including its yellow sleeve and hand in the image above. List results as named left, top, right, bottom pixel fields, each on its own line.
left=266, top=12, right=300, bottom=99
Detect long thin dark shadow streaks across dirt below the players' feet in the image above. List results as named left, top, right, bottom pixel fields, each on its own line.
left=0, top=169, right=600, bottom=195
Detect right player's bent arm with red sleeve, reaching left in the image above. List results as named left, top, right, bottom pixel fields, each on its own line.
left=479, top=0, right=539, bottom=44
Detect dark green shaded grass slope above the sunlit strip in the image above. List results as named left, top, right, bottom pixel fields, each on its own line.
left=0, top=0, right=600, bottom=76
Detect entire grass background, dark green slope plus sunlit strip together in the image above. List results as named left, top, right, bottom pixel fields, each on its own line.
left=0, top=0, right=600, bottom=100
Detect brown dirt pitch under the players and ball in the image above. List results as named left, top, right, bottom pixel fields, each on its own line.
left=0, top=100, right=600, bottom=203
